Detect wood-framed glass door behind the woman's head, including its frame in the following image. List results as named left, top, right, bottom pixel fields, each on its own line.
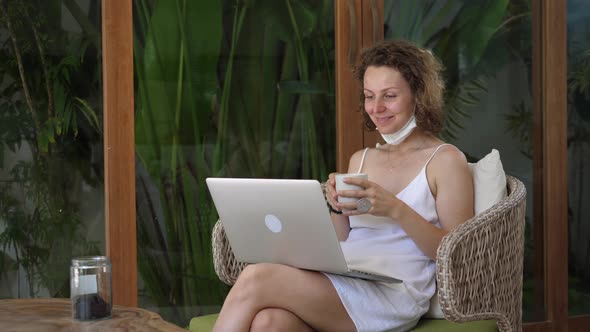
left=336, top=0, right=567, bottom=330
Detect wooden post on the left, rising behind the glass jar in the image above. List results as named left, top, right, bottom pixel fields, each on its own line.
left=102, top=0, right=137, bottom=307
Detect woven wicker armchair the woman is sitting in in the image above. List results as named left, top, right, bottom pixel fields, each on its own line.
left=212, top=176, right=526, bottom=331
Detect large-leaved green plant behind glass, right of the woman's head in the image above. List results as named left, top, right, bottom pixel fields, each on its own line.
left=385, top=0, right=530, bottom=141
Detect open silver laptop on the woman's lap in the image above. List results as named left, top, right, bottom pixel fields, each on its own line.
left=207, top=178, right=401, bottom=282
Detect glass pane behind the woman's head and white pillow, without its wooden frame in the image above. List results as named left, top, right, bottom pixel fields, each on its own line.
left=384, top=0, right=544, bottom=321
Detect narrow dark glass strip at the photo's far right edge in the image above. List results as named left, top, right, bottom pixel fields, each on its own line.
left=567, top=0, right=590, bottom=315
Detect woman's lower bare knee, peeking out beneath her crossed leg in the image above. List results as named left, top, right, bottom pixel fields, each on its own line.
left=250, top=308, right=313, bottom=332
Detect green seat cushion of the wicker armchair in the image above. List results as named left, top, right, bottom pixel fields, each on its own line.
left=189, top=314, right=497, bottom=332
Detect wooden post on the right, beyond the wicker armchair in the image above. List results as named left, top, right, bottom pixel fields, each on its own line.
left=533, top=1, right=568, bottom=331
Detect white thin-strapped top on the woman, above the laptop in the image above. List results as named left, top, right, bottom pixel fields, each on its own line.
left=341, top=144, right=450, bottom=302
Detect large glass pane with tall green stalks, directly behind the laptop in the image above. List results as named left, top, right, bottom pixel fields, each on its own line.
left=133, top=0, right=336, bottom=326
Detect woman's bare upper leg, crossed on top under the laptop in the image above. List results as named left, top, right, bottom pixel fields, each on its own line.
left=213, top=264, right=356, bottom=332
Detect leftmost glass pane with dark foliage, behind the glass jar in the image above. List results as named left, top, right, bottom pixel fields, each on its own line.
left=0, top=0, right=105, bottom=298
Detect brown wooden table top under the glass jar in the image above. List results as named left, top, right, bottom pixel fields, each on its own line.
left=0, top=298, right=187, bottom=332
